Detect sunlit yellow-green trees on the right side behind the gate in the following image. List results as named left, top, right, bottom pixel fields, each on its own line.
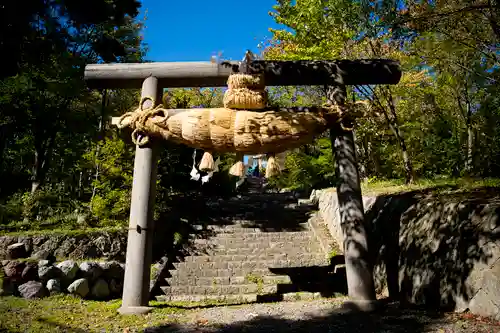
left=263, top=0, right=500, bottom=188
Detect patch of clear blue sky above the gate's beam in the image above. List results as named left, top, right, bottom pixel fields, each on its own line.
left=139, top=0, right=286, bottom=61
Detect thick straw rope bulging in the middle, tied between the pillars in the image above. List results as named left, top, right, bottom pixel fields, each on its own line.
left=117, top=74, right=367, bottom=153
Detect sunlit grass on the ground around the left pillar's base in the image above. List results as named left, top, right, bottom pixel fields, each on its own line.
left=0, top=295, right=188, bottom=332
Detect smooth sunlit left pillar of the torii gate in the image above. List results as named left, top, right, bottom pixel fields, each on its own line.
left=118, top=77, right=161, bottom=314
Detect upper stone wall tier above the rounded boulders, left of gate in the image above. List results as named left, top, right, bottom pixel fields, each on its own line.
left=0, top=231, right=127, bottom=262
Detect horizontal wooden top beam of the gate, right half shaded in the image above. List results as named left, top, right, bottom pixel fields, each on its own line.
left=85, top=59, right=401, bottom=89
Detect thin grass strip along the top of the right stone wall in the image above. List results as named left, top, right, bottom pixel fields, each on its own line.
left=361, top=178, right=500, bottom=195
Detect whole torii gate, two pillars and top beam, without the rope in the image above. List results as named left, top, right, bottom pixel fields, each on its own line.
left=85, top=59, right=401, bottom=314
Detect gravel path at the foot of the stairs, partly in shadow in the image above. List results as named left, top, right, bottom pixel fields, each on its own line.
left=146, top=299, right=500, bottom=333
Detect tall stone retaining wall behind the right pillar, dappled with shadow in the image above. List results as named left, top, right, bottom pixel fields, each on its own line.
left=311, top=189, right=500, bottom=320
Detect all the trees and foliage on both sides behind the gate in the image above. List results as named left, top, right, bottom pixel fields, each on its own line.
left=0, top=0, right=500, bottom=244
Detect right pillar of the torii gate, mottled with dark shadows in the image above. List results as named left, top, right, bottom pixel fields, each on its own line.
left=328, top=85, right=377, bottom=311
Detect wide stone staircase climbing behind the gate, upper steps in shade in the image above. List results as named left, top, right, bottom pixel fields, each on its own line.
left=157, top=193, right=348, bottom=303
